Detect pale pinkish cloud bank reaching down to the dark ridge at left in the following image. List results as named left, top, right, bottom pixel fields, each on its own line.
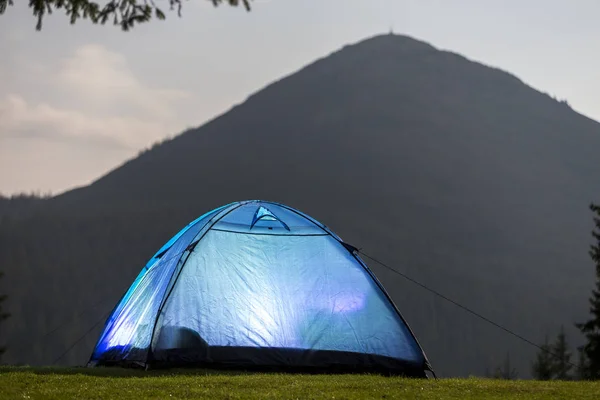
left=0, top=44, right=193, bottom=193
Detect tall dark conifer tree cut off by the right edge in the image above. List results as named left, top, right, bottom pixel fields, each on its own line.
left=576, top=204, right=600, bottom=379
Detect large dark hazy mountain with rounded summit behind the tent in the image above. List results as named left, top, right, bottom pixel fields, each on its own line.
left=0, top=35, right=600, bottom=376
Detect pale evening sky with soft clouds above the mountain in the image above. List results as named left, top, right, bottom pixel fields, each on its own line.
left=0, top=0, right=600, bottom=195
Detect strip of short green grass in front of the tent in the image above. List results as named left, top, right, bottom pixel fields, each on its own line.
left=0, top=367, right=600, bottom=400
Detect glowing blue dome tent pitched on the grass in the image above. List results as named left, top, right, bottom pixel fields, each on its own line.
left=88, top=200, right=431, bottom=376
